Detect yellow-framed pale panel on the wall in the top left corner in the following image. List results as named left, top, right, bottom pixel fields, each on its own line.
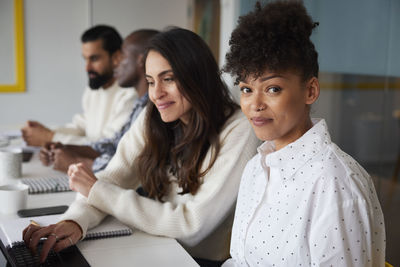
left=0, top=0, right=25, bottom=92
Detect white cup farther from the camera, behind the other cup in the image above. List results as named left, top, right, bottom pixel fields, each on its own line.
left=0, top=148, right=22, bottom=184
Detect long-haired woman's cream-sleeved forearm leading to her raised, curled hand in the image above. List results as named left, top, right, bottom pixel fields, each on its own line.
left=88, top=181, right=211, bottom=238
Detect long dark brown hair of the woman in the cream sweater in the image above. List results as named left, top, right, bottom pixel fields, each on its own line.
left=136, top=28, right=238, bottom=200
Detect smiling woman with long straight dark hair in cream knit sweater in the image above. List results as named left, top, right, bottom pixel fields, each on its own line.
left=24, top=28, right=259, bottom=265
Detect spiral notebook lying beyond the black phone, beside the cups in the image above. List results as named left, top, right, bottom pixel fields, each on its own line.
left=21, top=176, right=71, bottom=194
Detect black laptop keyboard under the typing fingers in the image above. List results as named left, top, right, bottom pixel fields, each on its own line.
left=8, top=243, right=62, bottom=267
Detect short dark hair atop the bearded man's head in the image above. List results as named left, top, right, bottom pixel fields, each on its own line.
left=81, top=25, right=122, bottom=55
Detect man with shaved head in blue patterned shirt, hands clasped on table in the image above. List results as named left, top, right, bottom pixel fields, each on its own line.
left=40, top=29, right=158, bottom=172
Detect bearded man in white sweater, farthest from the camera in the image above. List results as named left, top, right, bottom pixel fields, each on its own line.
left=21, top=25, right=137, bottom=146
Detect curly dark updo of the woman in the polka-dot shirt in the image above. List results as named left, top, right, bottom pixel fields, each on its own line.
left=223, top=1, right=318, bottom=84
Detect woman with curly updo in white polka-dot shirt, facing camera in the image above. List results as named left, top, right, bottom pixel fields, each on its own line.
left=224, top=1, right=385, bottom=266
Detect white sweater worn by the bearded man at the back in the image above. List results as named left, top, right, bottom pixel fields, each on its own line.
left=52, top=82, right=138, bottom=145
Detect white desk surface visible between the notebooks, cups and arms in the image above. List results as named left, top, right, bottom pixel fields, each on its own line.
left=0, top=154, right=198, bottom=267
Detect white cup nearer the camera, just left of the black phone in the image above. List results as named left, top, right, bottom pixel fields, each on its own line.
left=0, top=183, right=29, bottom=214
